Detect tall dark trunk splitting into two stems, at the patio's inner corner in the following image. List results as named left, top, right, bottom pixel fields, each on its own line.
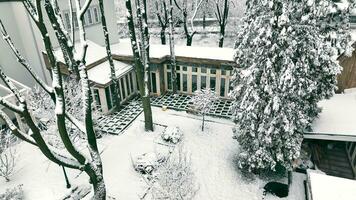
left=126, top=0, right=153, bottom=131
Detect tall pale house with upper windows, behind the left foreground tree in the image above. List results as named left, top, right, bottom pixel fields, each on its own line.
left=0, top=0, right=119, bottom=87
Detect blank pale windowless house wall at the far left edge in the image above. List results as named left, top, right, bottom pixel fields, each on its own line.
left=0, top=2, right=49, bottom=87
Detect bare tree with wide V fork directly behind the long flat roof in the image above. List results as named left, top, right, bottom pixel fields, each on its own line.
left=174, top=0, right=204, bottom=46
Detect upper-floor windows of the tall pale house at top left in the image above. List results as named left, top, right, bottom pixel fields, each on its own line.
left=63, top=6, right=101, bottom=30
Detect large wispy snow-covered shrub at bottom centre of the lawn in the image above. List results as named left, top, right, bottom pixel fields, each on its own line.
left=151, top=145, right=198, bottom=200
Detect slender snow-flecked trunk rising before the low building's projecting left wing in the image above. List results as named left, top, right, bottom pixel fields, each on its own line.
left=99, top=0, right=120, bottom=109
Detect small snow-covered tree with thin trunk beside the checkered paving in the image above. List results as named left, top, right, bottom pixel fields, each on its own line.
left=191, top=88, right=219, bottom=131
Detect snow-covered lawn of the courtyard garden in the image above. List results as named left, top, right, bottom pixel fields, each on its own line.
left=0, top=108, right=304, bottom=200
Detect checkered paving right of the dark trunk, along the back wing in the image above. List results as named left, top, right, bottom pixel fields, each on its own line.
left=151, top=93, right=232, bottom=118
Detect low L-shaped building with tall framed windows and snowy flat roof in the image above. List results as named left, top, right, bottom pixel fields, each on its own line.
left=48, top=40, right=235, bottom=113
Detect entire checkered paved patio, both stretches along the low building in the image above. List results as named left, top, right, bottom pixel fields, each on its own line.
left=97, top=93, right=231, bottom=135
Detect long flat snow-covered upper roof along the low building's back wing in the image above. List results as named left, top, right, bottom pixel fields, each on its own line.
left=112, top=39, right=234, bottom=62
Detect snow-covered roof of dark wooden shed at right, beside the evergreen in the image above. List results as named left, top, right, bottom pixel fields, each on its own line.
left=304, top=89, right=356, bottom=141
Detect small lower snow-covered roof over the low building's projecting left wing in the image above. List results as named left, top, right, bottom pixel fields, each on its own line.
left=88, top=60, right=133, bottom=85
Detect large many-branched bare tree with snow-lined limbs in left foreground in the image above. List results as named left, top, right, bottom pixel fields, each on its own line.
left=0, top=0, right=106, bottom=200
